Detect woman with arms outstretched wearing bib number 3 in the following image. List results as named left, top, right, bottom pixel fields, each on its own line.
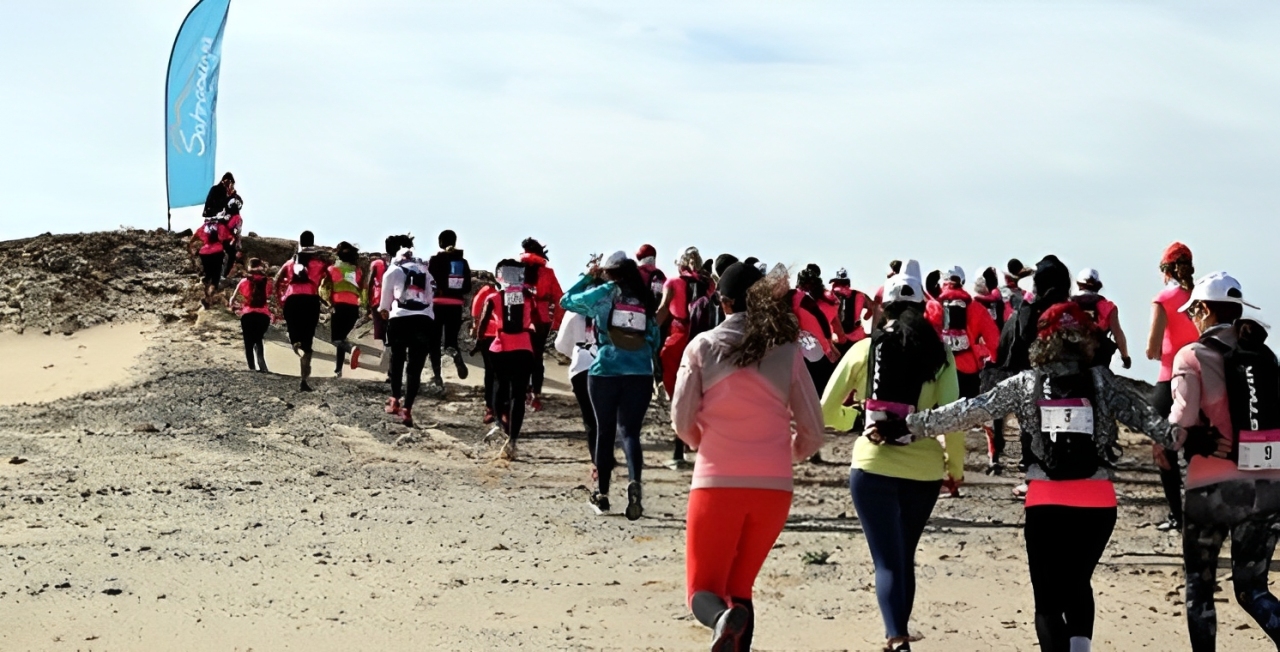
left=867, top=301, right=1179, bottom=652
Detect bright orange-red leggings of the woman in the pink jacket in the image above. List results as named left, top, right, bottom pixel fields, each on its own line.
left=685, top=488, right=791, bottom=603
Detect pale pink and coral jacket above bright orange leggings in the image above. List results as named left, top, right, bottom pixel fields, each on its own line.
left=671, top=313, right=823, bottom=491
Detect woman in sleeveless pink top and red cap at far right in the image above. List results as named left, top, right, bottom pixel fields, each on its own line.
left=1147, top=242, right=1199, bottom=532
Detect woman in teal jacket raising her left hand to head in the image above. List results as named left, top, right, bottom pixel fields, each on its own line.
left=561, top=251, right=659, bottom=520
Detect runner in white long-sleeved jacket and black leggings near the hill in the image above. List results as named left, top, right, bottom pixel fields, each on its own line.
left=378, top=236, right=435, bottom=428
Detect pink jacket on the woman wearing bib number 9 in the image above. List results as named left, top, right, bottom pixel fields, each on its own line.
left=1169, top=325, right=1280, bottom=489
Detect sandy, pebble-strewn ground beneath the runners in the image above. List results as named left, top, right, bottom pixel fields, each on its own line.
left=0, top=315, right=1271, bottom=651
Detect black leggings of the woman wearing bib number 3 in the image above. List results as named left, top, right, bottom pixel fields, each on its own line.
left=1023, top=502, right=1116, bottom=652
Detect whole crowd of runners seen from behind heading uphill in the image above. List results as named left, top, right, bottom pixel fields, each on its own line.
left=192, top=174, right=1280, bottom=652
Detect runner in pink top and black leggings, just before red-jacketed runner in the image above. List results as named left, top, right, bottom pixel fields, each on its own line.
left=480, top=259, right=536, bottom=461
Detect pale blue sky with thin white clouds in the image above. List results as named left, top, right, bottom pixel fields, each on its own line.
left=0, top=0, right=1280, bottom=379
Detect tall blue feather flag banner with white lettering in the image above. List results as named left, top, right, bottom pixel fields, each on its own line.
left=165, top=0, right=230, bottom=209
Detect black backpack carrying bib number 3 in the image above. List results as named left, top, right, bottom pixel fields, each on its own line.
left=1036, top=373, right=1102, bottom=480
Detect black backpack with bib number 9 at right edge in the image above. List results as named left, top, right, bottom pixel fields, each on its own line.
left=1201, top=320, right=1280, bottom=470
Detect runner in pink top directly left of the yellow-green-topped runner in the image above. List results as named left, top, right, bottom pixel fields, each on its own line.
left=275, top=231, right=329, bottom=392
